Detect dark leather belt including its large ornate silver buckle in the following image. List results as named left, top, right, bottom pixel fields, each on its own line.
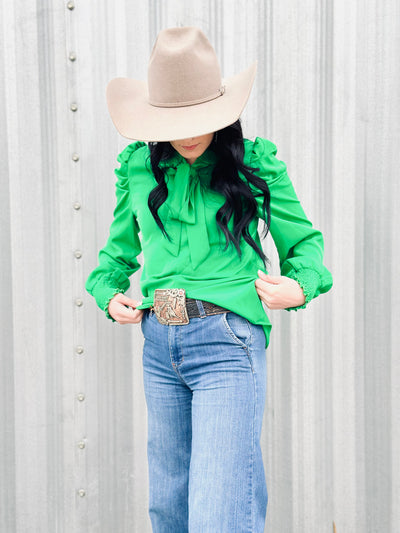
left=152, top=289, right=229, bottom=326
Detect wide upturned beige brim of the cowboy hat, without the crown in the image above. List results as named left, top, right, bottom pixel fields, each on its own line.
left=107, top=61, right=257, bottom=141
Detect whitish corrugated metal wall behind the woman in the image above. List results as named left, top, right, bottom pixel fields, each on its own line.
left=0, top=0, right=400, bottom=533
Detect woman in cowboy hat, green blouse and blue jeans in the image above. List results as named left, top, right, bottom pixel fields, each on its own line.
left=87, top=27, right=332, bottom=533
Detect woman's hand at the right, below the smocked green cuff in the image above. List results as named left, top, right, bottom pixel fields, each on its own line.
left=255, top=270, right=306, bottom=309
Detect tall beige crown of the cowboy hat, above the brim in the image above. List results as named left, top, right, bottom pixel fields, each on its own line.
left=148, top=27, right=223, bottom=107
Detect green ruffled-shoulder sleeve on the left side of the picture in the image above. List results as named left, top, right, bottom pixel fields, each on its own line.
left=86, top=142, right=145, bottom=321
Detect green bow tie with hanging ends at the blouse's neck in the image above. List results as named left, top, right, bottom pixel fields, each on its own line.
left=162, top=150, right=216, bottom=268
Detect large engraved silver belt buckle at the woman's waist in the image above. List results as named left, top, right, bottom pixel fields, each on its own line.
left=153, top=289, right=189, bottom=326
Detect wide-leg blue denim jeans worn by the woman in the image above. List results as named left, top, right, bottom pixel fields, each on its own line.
left=142, top=303, right=267, bottom=533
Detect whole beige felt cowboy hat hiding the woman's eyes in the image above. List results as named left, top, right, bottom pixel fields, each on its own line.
left=107, top=27, right=257, bottom=141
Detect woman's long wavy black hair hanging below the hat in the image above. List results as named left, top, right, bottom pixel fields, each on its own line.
left=148, top=120, right=271, bottom=263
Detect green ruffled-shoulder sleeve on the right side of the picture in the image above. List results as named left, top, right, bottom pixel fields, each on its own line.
left=251, top=137, right=332, bottom=310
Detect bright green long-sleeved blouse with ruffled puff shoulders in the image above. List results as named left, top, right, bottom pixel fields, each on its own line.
left=86, top=137, right=332, bottom=345
